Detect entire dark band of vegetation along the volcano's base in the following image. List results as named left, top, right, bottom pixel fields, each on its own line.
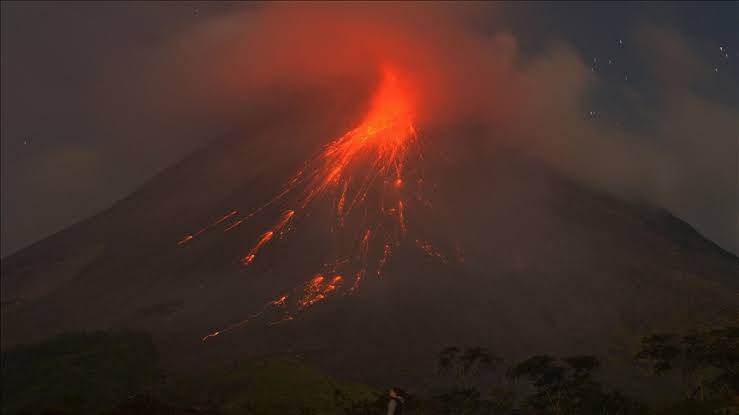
left=2, top=326, right=739, bottom=415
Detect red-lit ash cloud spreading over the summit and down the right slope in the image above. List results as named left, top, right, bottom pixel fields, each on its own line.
left=3, top=3, right=739, bottom=255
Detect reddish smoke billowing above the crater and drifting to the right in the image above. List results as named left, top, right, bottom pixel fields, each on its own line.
left=125, top=4, right=739, bottom=254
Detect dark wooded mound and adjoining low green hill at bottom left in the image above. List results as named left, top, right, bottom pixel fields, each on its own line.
left=2, top=332, right=385, bottom=415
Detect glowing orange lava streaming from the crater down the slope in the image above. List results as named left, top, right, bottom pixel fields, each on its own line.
left=180, top=67, right=456, bottom=341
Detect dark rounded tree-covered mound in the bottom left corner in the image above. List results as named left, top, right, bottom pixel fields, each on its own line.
left=2, top=331, right=158, bottom=414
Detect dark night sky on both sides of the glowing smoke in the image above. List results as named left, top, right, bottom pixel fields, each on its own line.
left=1, top=2, right=739, bottom=256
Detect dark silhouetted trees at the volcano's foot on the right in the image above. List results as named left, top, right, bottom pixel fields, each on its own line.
left=414, top=327, right=739, bottom=415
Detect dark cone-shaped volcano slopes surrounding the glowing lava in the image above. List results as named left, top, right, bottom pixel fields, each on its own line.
left=2, top=101, right=739, bottom=394
